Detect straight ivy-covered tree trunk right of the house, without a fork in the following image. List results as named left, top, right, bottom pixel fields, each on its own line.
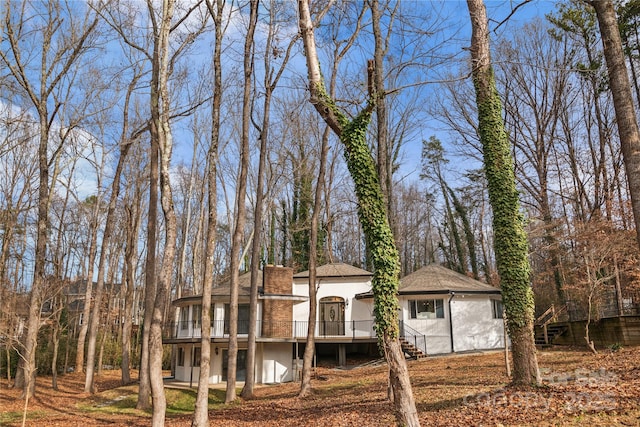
left=467, top=0, right=540, bottom=384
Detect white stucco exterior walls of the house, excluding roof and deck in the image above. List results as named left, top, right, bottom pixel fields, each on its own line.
left=170, top=272, right=504, bottom=383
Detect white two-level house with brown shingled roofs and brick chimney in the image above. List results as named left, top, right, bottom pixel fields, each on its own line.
left=164, top=263, right=504, bottom=383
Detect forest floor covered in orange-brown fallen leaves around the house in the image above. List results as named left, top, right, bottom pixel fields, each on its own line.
left=0, top=348, right=640, bottom=427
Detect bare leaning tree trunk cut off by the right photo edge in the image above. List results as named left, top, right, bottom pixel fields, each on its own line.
left=590, top=0, right=640, bottom=249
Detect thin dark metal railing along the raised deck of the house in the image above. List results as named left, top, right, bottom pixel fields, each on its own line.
left=163, top=320, right=376, bottom=339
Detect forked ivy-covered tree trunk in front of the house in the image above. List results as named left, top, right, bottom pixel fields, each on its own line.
left=298, top=0, right=420, bottom=427
